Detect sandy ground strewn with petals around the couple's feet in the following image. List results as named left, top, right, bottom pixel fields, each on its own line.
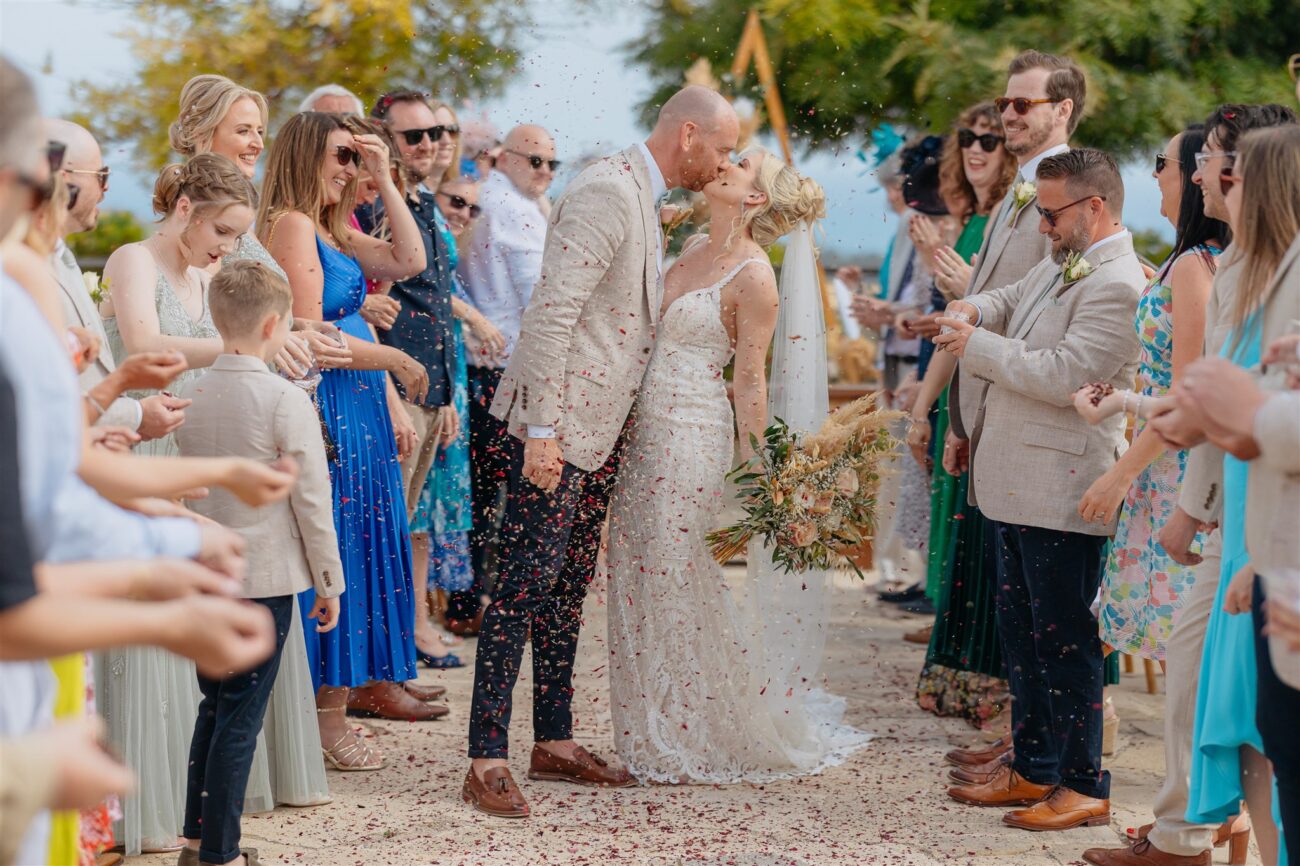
left=130, top=566, right=1258, bottom=866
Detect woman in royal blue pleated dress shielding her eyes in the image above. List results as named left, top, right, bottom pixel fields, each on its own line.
left=257, top=112, right=428, bottom=770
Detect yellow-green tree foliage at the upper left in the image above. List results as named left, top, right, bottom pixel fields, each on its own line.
left=73, top=0, right=528, bottom=168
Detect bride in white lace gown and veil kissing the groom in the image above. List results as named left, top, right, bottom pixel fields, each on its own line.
left=608, top=148, right=870, bottom=783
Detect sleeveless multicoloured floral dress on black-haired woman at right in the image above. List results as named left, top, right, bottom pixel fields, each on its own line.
left=1100, top=246, right=1221, bottom=661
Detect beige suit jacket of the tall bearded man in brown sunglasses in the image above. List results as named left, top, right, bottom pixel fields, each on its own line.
left=949, top=179, right=1052, bottom=437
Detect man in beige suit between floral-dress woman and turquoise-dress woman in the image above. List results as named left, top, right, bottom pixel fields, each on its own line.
left=1084, top=104, right=1295, bottom=866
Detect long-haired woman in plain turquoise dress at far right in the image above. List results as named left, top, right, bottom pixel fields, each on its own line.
left=1187, top=135, right=1292, bottom=866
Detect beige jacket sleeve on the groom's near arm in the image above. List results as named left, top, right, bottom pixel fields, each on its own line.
left=510, top=179, right=631, bottom=428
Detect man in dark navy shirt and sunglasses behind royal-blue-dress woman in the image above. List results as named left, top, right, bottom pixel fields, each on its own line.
left=361, top=90, right=463, bottom=668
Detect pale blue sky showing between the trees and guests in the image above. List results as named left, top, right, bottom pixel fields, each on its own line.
left=0, top=0, right=1173, bottom=257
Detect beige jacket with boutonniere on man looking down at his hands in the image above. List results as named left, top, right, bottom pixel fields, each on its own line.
left=962, top=237, right=1145, bottom=536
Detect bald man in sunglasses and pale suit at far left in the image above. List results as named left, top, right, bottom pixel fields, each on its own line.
left=44, top=118, right=186, bottom=440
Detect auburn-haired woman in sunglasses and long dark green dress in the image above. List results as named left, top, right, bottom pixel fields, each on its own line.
left=907, top=103, right=1017, bottom=724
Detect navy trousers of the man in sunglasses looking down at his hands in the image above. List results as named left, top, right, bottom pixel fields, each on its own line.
left=987, top=520, right=1110, bottom=800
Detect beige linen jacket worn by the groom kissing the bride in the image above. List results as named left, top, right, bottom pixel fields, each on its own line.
left=491, top=147, right=660, bottom=472
